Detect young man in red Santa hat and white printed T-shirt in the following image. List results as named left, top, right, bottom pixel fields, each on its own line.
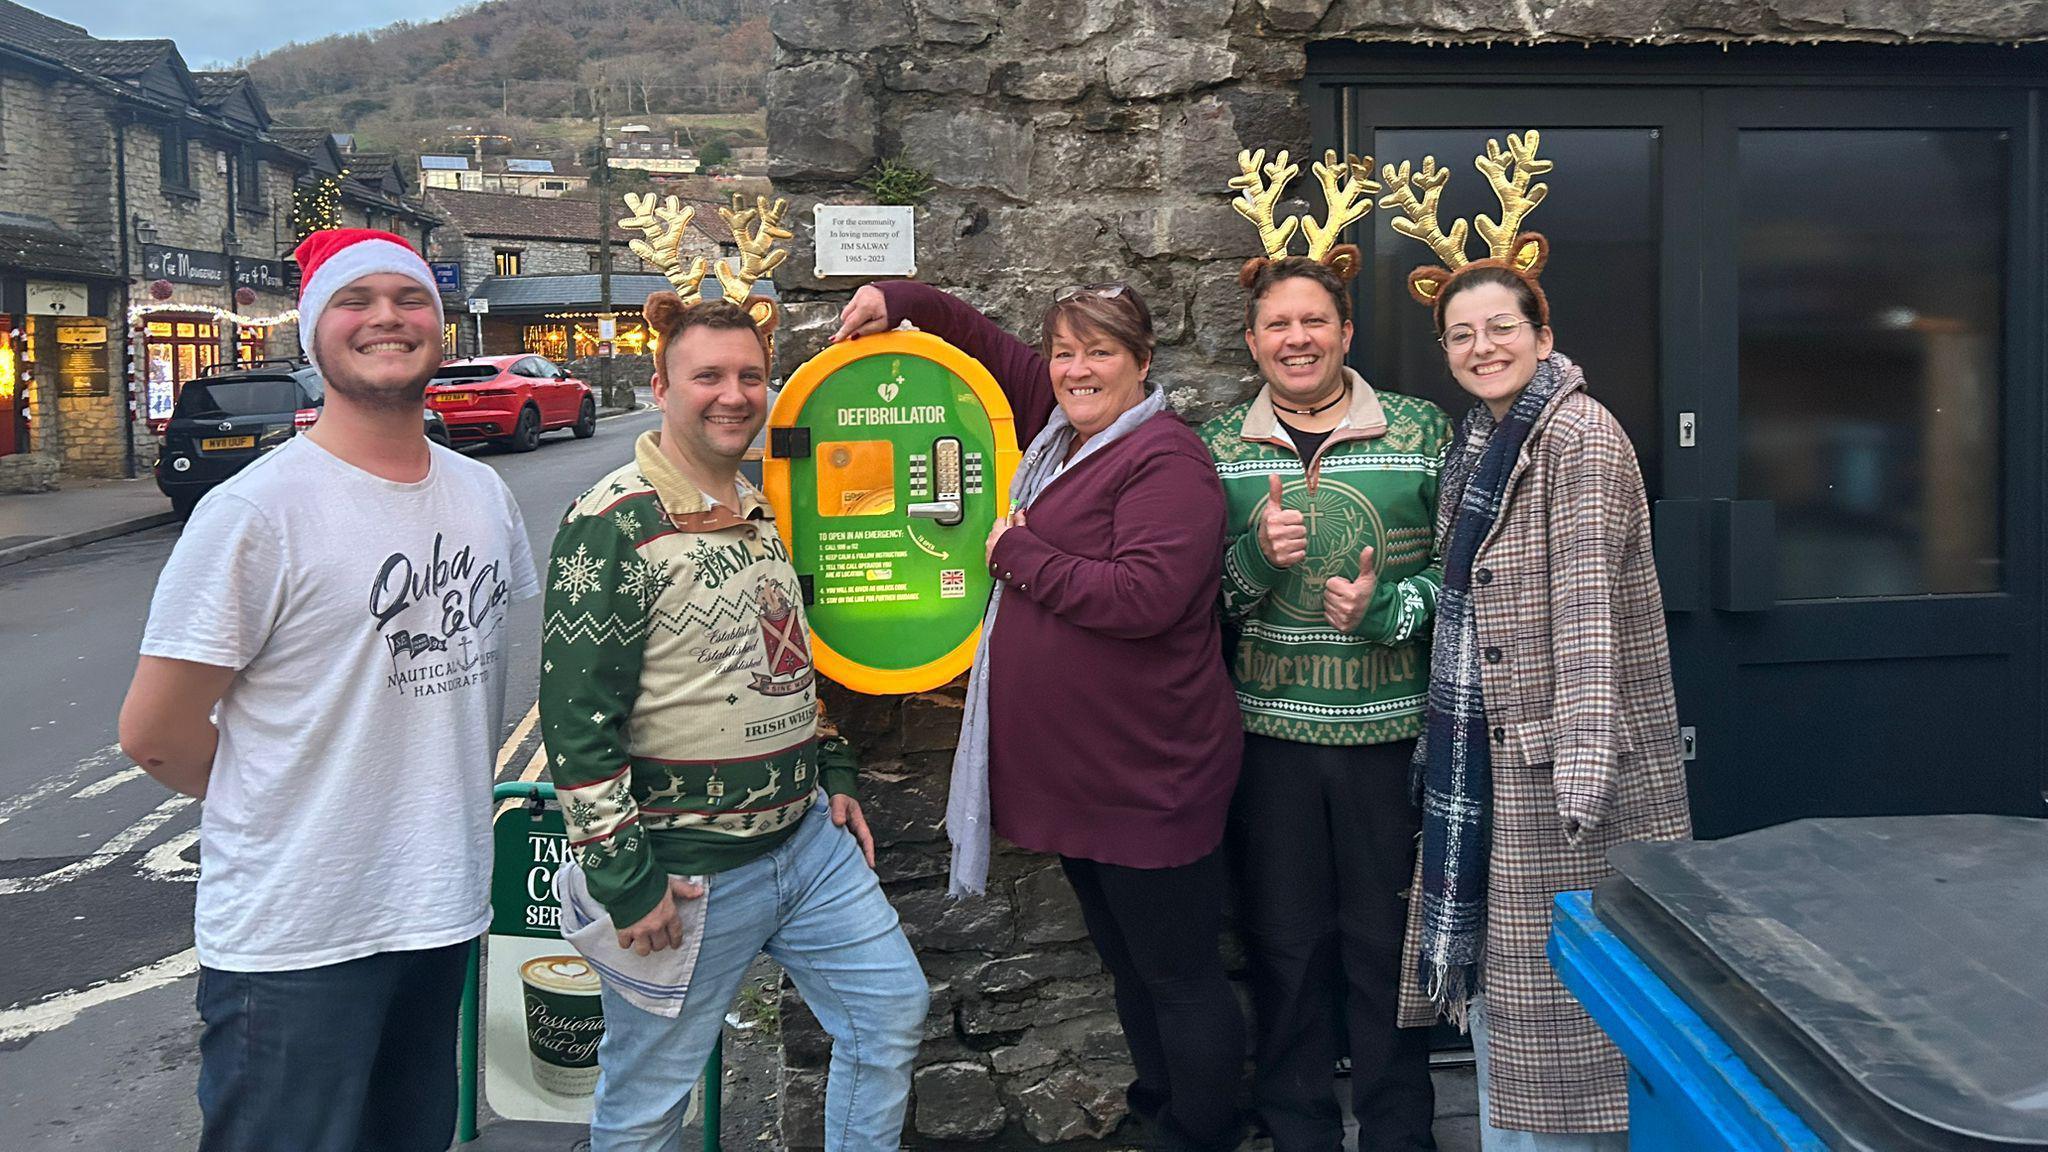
left=121, top=230, right=539, bottom=1152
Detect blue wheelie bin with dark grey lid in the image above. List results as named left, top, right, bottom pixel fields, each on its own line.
left=1550, top=816, right=2048, bottom=1152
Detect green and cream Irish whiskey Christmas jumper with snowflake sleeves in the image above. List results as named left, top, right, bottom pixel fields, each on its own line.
left=541, top=433, right=854, bottom=927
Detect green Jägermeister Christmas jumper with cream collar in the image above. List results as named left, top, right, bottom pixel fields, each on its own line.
left=1202, top=369, right=1452, bottom=744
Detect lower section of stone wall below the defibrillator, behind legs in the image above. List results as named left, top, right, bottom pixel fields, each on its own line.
left=776, top=681, right=1137, bottom=1150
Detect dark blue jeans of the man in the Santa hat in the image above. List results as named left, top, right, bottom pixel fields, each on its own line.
left=199, top=941, right=471, bottom=1152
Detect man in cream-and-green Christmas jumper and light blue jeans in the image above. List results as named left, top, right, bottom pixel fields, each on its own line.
left=541, top=293, right=928, bottom=1152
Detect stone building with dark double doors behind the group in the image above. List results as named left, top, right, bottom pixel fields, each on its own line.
left=768, top=0, right=2048, bottom=1148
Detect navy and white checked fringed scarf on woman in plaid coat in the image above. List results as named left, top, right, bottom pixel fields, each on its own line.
left=1413, top=353, right=1579, bottom=1029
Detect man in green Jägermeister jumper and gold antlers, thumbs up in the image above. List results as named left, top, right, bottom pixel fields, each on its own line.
left=1202, top=152, right=1452, bottom=1152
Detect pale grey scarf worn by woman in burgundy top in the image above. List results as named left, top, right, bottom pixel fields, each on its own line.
left=946, top=387, right=1165, bottom=896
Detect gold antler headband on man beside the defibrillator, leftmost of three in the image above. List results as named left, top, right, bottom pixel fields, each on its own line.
left=618, top=193, right=793, bottom=342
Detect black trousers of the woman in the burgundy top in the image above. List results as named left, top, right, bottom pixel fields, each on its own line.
left=1059, top=851, right=1245, bottom=1152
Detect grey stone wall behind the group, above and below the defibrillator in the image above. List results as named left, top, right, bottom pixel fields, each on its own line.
left=768, top=0, right=2048, bottom=1148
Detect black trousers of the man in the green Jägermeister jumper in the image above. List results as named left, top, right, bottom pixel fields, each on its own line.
left=1231, top=734, right=1436, bottom=1152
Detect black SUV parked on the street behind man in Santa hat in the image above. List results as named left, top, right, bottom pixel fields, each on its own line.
left=156, top=361, right=449, bottom=517
